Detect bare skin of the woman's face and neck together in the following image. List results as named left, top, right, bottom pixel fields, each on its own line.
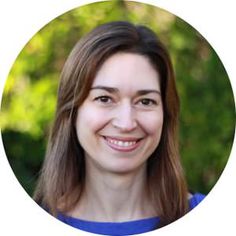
left=72, top=53, right=163, bottom=222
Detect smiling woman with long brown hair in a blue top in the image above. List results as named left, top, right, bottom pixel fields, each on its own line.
left=35, top=22, right=206, bottom=235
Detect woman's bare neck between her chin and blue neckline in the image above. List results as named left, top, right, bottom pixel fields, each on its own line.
left=72, top=162, right=156, bottom=222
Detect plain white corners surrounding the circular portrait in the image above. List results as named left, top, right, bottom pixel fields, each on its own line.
left=0, top=0, right=236, bottom=236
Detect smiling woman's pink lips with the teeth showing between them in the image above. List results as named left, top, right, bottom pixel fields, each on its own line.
left=103, top=136, right=142, bottom=152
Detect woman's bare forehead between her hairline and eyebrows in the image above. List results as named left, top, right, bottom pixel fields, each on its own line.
left=92, top=53, right=160, bottom=90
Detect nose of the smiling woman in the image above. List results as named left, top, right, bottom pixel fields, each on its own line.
left=112, top=102, right=137, bottom=132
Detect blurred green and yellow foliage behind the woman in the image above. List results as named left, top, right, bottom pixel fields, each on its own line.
left=0, top=1, right=235, bottom=194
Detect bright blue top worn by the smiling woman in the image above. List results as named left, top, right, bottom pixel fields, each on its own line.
left=58, top=193, right=205, bottom=236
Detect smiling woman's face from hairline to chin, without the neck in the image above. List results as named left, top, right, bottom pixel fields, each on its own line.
left=76, top=53, right=163, bottom=173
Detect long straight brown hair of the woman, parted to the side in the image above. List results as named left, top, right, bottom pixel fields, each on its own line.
left=34, top=21, right=188, bottom=226
